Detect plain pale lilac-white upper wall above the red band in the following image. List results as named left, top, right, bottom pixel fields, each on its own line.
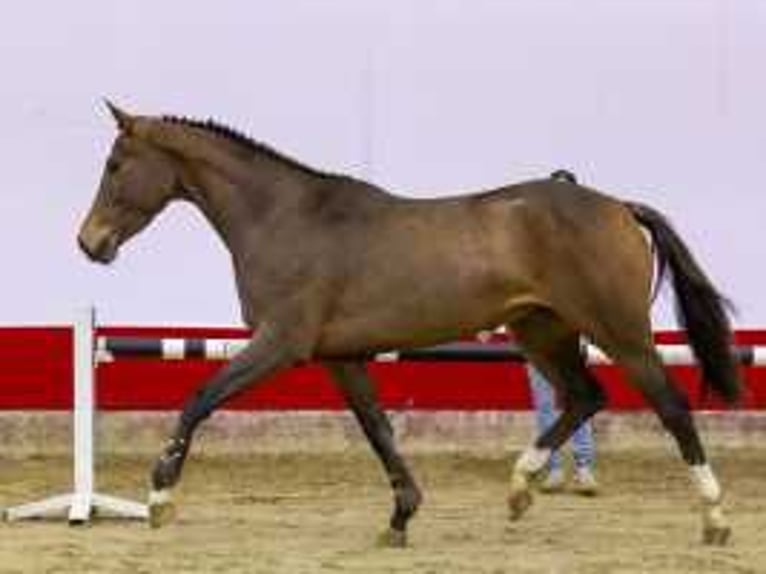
left=0, top=0, right=766, bottom=327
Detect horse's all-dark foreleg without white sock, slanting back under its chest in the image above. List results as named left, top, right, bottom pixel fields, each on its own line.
left=326, top=362, right=422, bottom=546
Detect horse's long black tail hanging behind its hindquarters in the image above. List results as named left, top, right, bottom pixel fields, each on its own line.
left=626, top=203, right=742, bottom=403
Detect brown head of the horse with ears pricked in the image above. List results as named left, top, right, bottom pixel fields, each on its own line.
left=78, top=102, right=180, bottom=263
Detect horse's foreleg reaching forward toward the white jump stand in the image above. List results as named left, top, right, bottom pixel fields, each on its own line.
left=149, top=328, right=295, bottom=528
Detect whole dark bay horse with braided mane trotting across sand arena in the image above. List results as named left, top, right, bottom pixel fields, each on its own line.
left=79, top=104, right=740, bottom=545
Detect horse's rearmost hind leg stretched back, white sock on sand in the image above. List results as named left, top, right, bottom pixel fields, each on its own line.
left=610, top=343, right=731, bottom=545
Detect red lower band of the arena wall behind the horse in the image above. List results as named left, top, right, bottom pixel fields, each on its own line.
left=0, top=327, right=766, bottom=411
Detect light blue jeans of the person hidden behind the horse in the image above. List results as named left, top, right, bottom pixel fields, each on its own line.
left=527, top=363, right=596, bottom=471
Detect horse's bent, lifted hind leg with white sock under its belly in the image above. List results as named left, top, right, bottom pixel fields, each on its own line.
left=508, top=308, right=605, bottom=520
